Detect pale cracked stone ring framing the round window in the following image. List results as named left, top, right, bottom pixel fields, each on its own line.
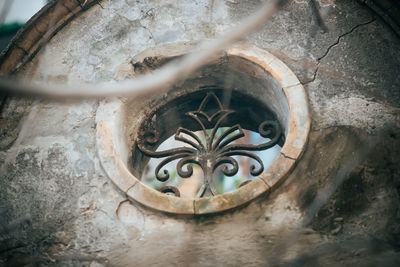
left=96, top=44, right=310, bottom=214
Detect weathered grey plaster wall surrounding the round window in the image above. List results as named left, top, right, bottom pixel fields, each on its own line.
left=0, top=0, right=400, bottom=266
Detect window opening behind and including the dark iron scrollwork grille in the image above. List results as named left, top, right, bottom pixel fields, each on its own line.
left=132, top=89, right=284, bottom=198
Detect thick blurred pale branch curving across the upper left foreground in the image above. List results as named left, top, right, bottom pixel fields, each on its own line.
left=0, top=0, right=287, bottom=98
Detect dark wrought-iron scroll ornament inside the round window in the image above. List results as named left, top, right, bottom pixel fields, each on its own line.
left=137, top=93, right=282, bottom=197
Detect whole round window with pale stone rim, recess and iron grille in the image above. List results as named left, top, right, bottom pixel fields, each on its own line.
left=97, top=44, right=310, bottom=214
